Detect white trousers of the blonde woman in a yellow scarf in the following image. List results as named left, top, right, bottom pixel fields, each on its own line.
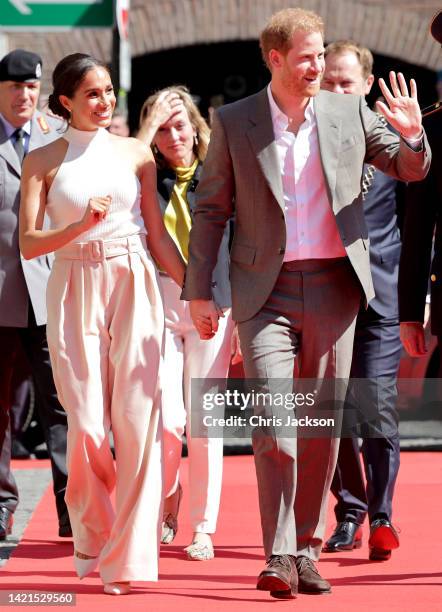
left=160, top=275, right=233, bottom=533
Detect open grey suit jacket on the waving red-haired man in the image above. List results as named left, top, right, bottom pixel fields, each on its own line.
left=182, top=89, right=430, bottom=321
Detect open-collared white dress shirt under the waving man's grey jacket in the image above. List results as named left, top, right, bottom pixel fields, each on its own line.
left=267, top=85, right=346, bottom=261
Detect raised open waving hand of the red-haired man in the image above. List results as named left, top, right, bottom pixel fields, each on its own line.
left=376, top=71, right=422, bottom=139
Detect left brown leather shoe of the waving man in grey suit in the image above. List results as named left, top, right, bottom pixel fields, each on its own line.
left=256, top=555, right=298, bottom=599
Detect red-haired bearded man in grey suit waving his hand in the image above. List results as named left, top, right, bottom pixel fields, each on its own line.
left=182, top=9, right=429, bottom=598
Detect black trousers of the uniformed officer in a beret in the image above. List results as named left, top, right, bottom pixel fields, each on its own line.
left=0, top=307, right=69, bottom=524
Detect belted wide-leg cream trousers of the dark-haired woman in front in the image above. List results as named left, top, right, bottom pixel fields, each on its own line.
left=47, top=236, right=164, bottom=583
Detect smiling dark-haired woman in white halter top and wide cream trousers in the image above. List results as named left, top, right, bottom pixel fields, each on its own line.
left=20, top=53, right=184, bottom=595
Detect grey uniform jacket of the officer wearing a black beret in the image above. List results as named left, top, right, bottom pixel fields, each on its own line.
left=0, top=111, right=61, bottom=327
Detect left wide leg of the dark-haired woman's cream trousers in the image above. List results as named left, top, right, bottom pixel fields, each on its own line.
left=47, top=258, right=115, bottom=557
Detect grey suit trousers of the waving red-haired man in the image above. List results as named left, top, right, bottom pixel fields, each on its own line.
left=238, top=258, right=361, bottom=560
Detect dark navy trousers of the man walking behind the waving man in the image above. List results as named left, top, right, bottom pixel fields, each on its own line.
left=331, top=307, right=401, bottom=524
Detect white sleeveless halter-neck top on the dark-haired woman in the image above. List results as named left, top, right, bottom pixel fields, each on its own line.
left=46, top=127, right=146, bottom=242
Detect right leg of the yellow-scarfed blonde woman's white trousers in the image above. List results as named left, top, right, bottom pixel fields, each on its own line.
left=184, top=304, right=233, bottom=533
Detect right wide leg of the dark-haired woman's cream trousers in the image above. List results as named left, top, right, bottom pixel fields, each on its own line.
left=100, top=252, right=164, bottom=583
